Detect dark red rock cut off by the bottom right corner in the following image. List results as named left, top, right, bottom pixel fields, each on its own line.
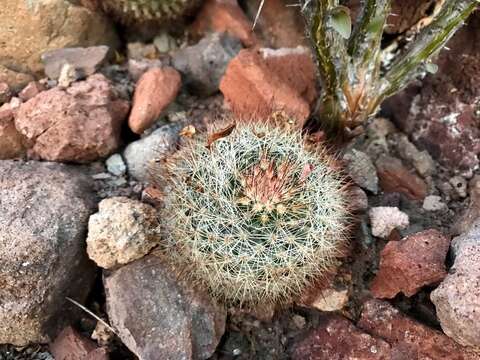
left=357, top=300, right=480, bottom=360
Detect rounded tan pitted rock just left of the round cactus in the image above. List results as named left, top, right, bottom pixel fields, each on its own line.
left=87, top=197, right=160, bottom=269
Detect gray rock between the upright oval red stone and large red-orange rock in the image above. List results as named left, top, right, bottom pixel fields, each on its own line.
left=172, top=33, right=242, bottom=96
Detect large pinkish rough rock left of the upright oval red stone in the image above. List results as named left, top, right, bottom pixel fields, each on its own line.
left=15, top=74, right=128, bottom=163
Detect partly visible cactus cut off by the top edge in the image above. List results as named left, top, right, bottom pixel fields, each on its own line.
left=101, top=0, right=200, bottom=24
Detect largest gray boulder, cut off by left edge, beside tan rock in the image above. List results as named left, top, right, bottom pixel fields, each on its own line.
left=0, top=160, right=95, bottom=346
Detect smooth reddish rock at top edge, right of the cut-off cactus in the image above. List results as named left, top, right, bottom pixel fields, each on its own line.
left=192, top=0, right=257, bottom=47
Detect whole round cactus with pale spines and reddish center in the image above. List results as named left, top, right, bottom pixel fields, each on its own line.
left=153, top=124, right=348, bottom=307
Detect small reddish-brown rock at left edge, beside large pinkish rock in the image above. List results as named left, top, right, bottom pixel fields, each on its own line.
left=0, top=104, right=24, bottom=160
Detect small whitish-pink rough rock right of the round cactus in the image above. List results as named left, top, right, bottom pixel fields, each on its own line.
left=369, top=206, right=409, bottom=239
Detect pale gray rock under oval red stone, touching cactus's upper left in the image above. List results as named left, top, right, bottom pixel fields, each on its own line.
left=123, top=124, right=181, bottom=182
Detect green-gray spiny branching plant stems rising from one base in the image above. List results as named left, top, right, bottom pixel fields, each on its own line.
left=303, top=0, right=479, bottom=135
